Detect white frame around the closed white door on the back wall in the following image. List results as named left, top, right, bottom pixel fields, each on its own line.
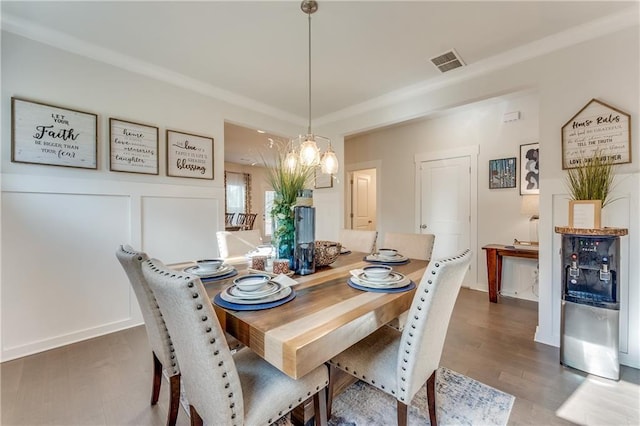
left=414, top=145, right=484, bottom=287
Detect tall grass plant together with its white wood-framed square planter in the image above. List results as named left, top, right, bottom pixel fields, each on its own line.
left=566, top=151, right=615, bottom=228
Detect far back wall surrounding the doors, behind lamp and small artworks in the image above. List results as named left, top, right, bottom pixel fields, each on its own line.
left=345, top=93, right=538, bottom=300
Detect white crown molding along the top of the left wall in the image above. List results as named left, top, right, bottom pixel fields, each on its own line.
left=2, top=13, right=307, bottom=125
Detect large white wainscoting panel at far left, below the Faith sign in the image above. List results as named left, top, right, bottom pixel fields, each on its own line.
left=2, top=192, right=132, bottom=359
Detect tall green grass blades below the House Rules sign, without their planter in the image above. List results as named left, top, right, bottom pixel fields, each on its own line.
left=566, top=151, right=615, bottom=207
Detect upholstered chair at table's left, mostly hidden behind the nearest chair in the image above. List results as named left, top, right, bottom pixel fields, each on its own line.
left=116, top=246, right=180, bottom=426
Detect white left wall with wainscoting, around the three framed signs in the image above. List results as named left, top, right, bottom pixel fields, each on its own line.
left=0, top=32, right=341, bottom=361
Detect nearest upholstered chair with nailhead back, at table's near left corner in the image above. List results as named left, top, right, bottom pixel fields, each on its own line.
left=142, top=259, right=329, bottom=426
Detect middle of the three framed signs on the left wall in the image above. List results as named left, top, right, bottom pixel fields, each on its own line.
left=109, top=118, right=158, bottom=175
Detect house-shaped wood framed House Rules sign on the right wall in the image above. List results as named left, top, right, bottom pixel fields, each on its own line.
left=562, top=99, right=631, bottom=170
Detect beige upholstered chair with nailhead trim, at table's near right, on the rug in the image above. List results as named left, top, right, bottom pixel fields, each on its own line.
left=328, top=250, right=471, bottom=426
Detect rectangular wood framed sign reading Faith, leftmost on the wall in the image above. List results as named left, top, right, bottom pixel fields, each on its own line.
left=11, top=97, right=98, bottom=169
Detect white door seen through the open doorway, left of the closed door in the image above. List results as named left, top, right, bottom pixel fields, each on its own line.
left=351, top=169, right=376, bottom=231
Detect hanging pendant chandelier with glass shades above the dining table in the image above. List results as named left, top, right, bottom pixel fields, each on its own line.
left=285, top=0, right=338, bottom=174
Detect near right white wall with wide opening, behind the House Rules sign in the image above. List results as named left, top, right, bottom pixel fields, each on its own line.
left=338, top=25, right=640, bottom=367
